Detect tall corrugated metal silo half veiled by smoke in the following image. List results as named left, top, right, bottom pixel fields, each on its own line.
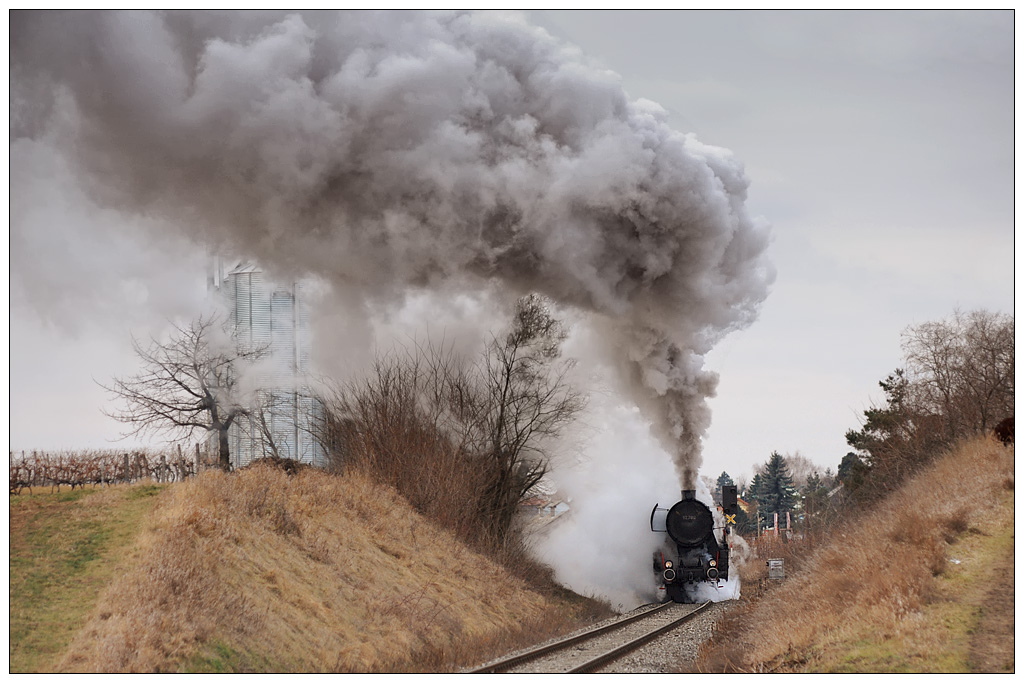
left=207, top=258, right=327, bottom=467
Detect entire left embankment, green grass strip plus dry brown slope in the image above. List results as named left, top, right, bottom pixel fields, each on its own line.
left=10, top=467, right=600, bottom=672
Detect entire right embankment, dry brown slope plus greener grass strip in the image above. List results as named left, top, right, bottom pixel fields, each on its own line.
left=699, top=439, right=1014, bottom=673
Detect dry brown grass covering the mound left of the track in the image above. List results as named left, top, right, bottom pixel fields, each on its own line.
left=61, top=467, right=598, bottom=672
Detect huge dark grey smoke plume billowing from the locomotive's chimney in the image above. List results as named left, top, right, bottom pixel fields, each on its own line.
left=10, top=7, right=772, bottom=487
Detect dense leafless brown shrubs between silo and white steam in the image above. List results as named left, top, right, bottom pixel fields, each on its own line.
left=325, top=296, right=584, bottom=559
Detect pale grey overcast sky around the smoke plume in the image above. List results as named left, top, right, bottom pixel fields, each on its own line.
left=10, top=11, right=1015, bottom=477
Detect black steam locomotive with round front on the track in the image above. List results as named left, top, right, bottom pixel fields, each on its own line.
left=650, top=486, right=736, bottom=602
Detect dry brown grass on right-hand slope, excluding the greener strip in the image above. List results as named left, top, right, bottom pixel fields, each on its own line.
left=700, top=438, right=1014, bottom=672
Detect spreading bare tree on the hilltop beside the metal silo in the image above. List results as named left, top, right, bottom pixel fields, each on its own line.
left=100, top=316, right=266, bottom=471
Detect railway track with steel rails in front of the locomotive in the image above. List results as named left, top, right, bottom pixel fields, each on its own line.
left=465, top=602, right=712, bottom=674
